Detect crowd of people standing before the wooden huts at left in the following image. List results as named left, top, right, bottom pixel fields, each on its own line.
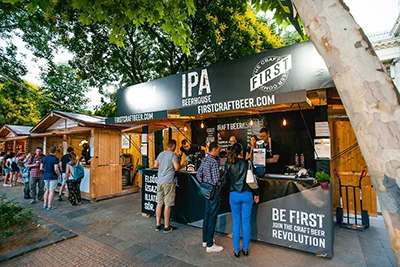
left=0, top=141, right=91, bottom=211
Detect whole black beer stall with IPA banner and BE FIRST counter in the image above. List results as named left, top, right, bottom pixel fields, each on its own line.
left=107, top=43, right=342, bottom=257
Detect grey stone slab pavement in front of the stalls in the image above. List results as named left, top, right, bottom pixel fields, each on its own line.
left=0, top=185, right=396, bottom=267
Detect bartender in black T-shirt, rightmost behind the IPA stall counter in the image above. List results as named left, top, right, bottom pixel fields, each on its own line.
left=259, top=127, right=283, bottom=173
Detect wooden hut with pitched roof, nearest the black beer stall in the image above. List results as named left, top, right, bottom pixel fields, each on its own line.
left=31, top=111, right=127, bottom=201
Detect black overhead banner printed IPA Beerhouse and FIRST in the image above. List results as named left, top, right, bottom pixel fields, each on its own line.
left=117, top=42, right=333, bottom=117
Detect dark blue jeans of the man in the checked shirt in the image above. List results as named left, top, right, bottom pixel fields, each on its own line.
left=203, top=188, right=221, bottom=247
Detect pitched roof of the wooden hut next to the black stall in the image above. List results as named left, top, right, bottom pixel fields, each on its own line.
left=31, top=110, right=128, bottom=133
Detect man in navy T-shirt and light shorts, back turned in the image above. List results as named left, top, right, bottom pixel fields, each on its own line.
left=40, top=146, right=61, bottom=210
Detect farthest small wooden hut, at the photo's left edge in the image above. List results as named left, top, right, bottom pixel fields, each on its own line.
left=0, top=124, right=35, bottom=153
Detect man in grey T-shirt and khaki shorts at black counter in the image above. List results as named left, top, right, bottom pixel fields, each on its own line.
left=154, top=139, right=180, bottom=233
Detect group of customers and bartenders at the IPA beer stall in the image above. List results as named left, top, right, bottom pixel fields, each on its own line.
left=154, top=128, right=280, bottom=257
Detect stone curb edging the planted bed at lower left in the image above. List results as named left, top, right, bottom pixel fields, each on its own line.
left=0, top=214, right=77, bottom=262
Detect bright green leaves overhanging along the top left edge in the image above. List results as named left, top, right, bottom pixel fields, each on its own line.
left=7, top=0, right=195, bottom=53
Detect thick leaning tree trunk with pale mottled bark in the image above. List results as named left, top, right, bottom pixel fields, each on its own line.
left=292, top=0, right=400, bottom=266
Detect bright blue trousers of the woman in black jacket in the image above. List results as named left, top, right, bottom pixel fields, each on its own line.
left=229, top=191, right=253, bottom=252
